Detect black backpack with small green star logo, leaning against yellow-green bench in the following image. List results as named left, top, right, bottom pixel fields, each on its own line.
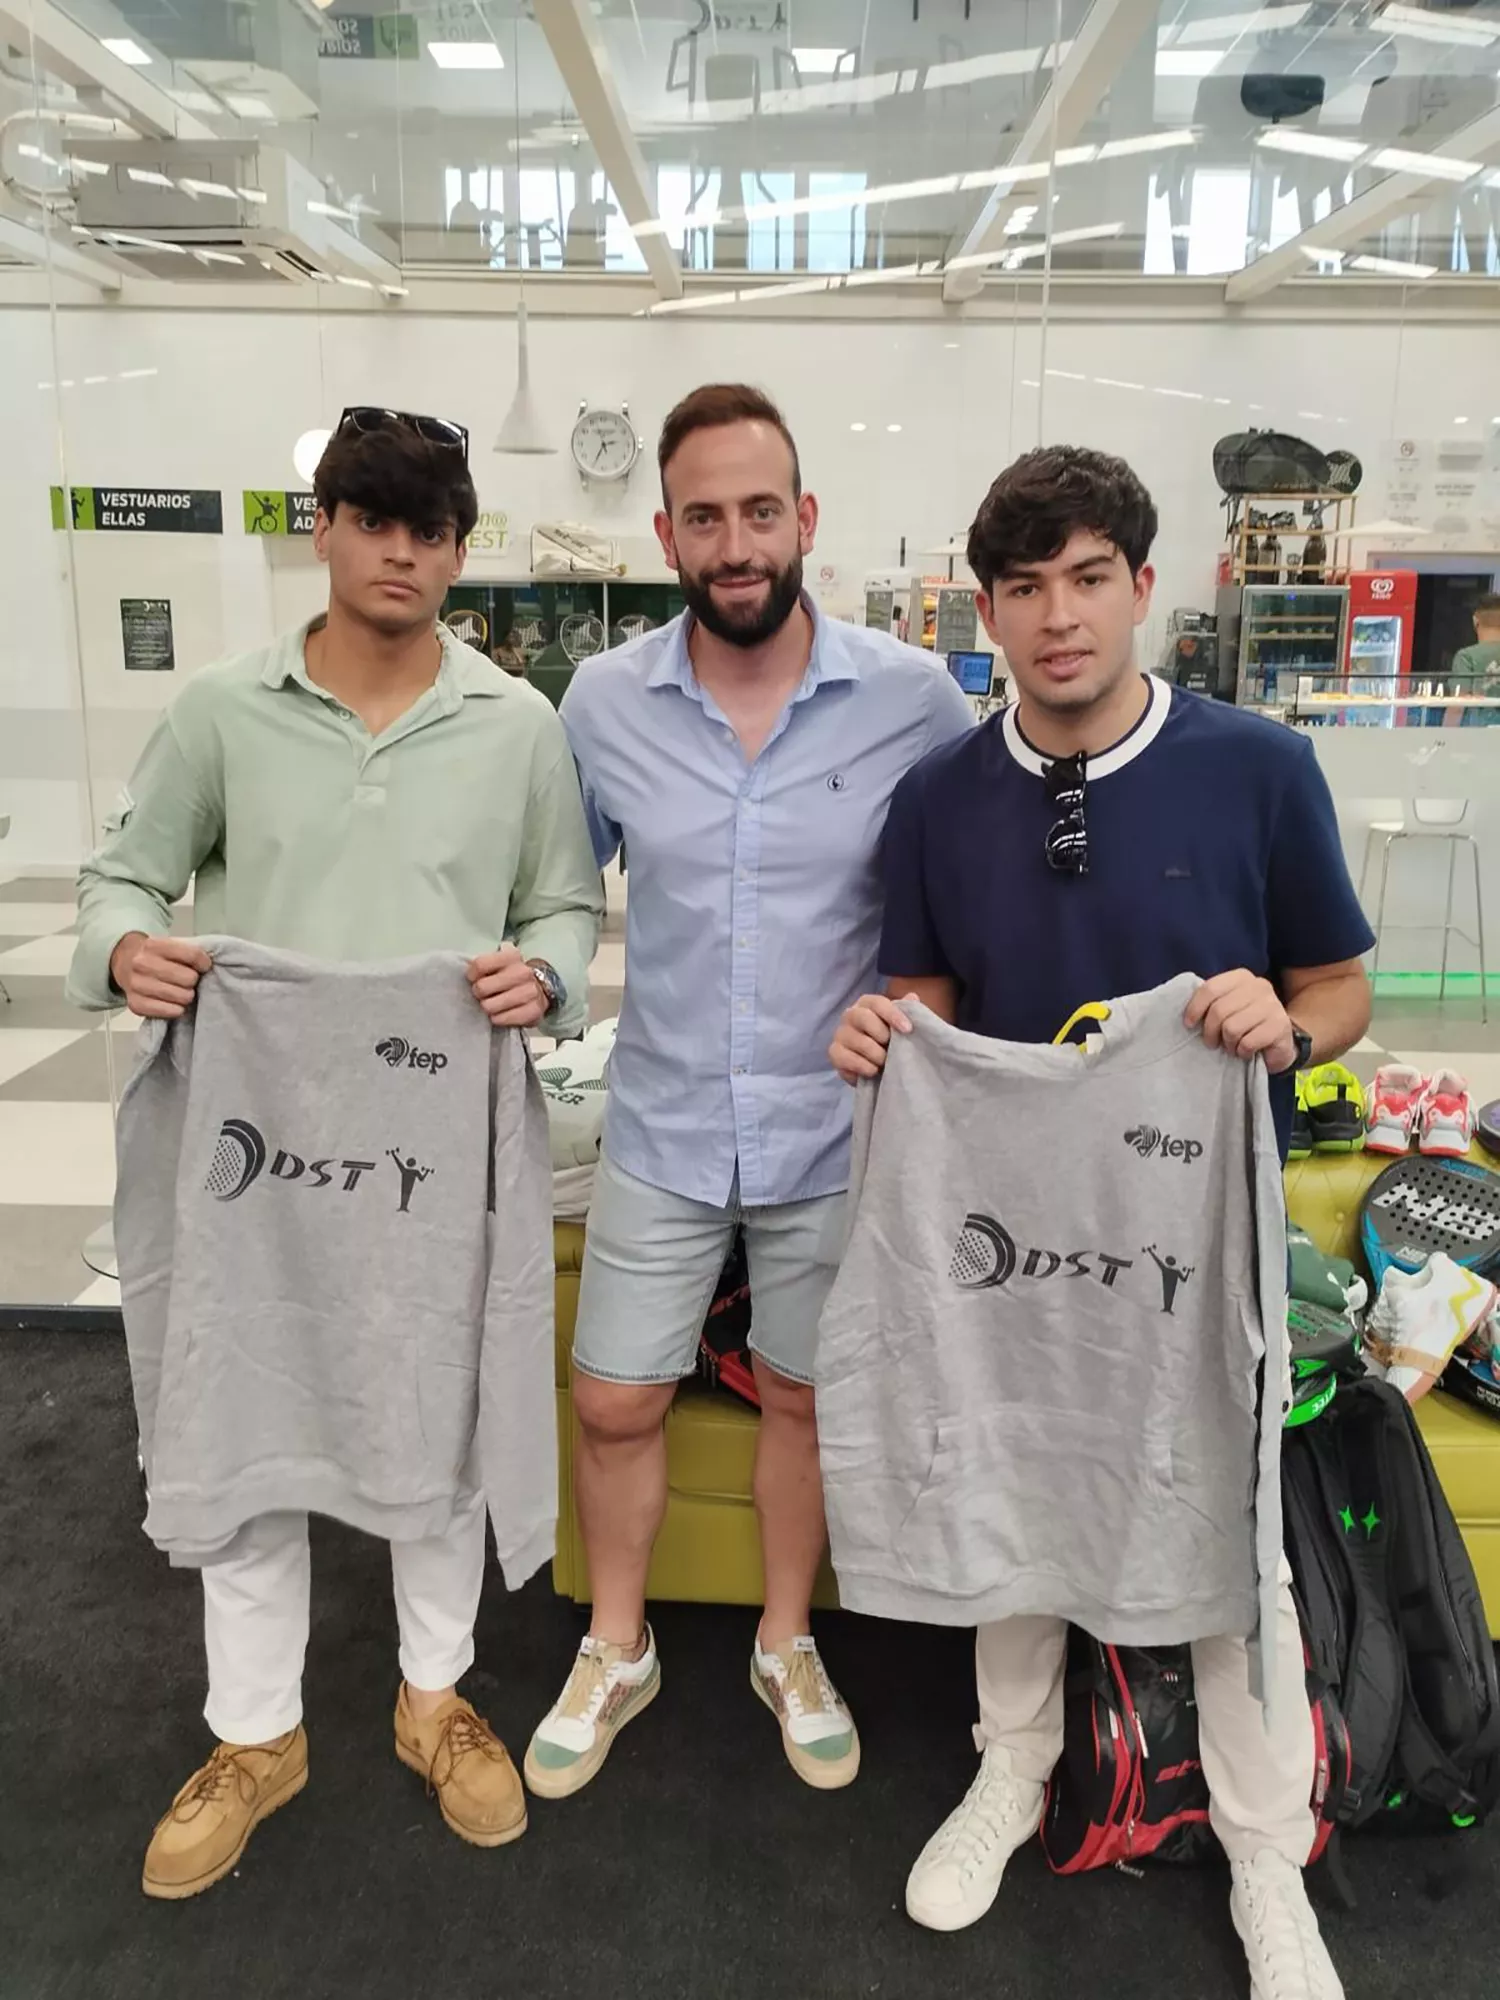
left=1282, top=1376, right=1500, bottom=1828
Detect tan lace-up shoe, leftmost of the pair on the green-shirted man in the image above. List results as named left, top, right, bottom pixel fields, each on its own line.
left=140, top=1724, right=308, bottom=1902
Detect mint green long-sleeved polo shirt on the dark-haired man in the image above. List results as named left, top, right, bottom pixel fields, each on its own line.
left=68, top=620, right=604, bottom=1034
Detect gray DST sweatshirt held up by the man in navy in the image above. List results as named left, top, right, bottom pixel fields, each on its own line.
left=818, top=974, right=1288, bottom=1712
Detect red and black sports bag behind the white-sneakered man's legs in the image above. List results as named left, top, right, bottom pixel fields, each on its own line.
left=1042, top=1628, right=1348, bottom=1874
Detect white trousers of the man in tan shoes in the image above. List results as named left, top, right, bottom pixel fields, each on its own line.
left=204, top=1494, right=484, bottom=1744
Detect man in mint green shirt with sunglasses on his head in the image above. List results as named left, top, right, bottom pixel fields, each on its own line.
left=68, top=408, right=602, bottom=1898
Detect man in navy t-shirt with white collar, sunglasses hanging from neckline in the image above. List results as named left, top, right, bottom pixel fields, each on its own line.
left=830, top=446, right=1374, bottom=2000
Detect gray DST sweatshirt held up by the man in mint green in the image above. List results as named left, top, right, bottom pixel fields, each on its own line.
left=114, top=938, right=558, bottom=1588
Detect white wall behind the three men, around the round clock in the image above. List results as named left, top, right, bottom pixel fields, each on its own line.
left=0, top=298, right=1500, bottom=952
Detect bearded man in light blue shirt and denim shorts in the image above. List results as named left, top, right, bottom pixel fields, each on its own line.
left=526, top=384, right=974, bottom=1798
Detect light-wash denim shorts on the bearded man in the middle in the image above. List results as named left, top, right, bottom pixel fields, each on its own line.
left=572, top=1156, right=846, bottom=1382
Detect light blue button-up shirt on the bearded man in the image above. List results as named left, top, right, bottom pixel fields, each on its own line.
left=562, top=600, right=974, bottom=1206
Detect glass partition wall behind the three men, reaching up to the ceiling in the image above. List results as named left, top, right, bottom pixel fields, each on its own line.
left=0, top=0, right=1500, bottom=1312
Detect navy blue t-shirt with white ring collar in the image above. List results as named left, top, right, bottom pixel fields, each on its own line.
left=880, top=676, right=1374, bottom=1156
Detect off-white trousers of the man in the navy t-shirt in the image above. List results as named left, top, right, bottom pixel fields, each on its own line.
left=974, top=1558, right=1316, bottom=1868
